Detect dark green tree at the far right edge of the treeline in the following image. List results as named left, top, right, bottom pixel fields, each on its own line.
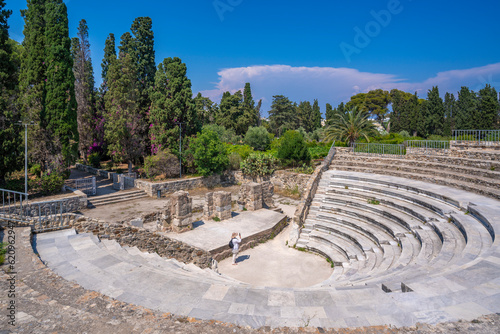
left=474, top=84, right=500, bottom=130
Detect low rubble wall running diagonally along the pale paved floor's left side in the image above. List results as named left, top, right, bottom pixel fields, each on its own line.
left=35, top=217, right=212, bottom=268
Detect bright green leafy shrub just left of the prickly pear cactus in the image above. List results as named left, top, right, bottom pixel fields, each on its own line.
left=189, top=129, right=229, bottom=176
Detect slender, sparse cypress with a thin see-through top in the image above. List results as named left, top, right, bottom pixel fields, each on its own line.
left=72, top=20, right=95, bottom=164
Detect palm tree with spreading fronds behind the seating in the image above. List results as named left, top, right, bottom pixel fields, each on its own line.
left=324, top=106, right=377, bottom=146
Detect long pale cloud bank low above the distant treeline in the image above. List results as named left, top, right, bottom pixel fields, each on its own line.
left=201, top=63, right=500, bottom=114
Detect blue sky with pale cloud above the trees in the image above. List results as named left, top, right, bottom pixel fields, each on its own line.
left=6, top=0, right=500, bottom=115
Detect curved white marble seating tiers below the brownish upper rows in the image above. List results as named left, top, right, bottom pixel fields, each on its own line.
left=296, top=163, right=500, bottom=291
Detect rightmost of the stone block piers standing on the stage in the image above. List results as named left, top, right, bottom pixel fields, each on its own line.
left=238, top=181, right=274, bottom=211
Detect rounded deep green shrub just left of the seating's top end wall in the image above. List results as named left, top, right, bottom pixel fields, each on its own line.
left=277, top=130, right=311, bottom=166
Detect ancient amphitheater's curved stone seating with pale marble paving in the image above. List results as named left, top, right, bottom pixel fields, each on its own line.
left=3, top=140, right=500, bottom=329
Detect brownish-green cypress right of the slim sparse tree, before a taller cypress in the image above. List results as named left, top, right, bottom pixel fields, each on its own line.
left=104, top=54, right=144, bottom=172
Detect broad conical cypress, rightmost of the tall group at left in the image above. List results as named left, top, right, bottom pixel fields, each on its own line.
left=149, top=57, right=194, bottom=153
